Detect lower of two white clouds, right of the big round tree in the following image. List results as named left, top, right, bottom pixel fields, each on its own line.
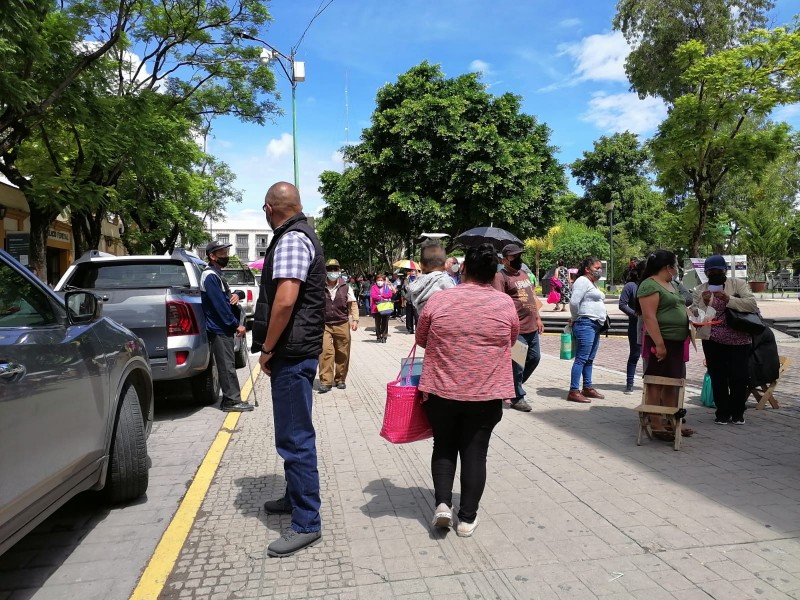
left=581, top=92, right=667, bottom=134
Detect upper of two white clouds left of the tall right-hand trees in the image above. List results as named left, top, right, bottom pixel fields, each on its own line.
left=562, top=31, right=630, bottom=82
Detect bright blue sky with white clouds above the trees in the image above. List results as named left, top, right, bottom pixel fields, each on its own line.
left=209, top=0, right=800, bottom=227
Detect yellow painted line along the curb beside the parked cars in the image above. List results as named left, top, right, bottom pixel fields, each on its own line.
left=130, top=365, right=261, bottom=600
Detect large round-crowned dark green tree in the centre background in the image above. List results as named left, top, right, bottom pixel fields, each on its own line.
left=336, top=62, right=566, bottom=240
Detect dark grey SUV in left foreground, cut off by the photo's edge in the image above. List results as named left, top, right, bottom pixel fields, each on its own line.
left=0, top=250, right=153, bottom=554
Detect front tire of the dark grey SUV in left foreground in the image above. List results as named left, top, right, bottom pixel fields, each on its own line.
left=103, top=385, right=149, bottom=504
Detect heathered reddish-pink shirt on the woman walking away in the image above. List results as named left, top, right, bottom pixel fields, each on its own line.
left=416, top=283, right=519, bottom=401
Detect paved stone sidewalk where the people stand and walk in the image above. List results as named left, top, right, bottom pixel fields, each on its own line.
left=161, top=320, right=800, bottom=600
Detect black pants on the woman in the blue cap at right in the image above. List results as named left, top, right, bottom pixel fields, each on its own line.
left=703, top=340, right=751, bottom=421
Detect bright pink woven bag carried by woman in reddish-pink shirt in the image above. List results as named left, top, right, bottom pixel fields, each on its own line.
left=380, top=344, right=433, bottom=444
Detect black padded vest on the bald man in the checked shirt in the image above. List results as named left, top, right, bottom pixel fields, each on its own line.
left=252, top=213, right=327, bottom=359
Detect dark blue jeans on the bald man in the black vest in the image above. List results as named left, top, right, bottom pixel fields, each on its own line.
left=270, top=356, right=322, bottom=533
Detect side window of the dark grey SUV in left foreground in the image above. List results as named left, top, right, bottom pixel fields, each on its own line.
left=0, top=263, right=56, bottom=327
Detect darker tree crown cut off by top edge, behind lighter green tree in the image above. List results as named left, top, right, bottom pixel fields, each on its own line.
left=613, top=0, right=775, bottom=103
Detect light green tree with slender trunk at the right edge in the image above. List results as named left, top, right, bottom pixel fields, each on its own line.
left=651, top=28, right=800, bottom=256
